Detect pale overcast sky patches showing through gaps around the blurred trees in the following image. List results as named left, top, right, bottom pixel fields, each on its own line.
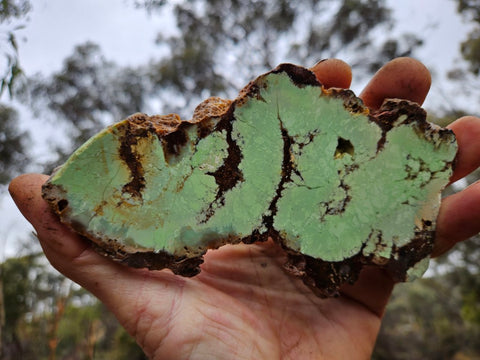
left=0, top=0, right=476, bottom=261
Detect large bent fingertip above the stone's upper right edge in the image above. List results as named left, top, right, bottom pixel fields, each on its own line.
left=360, top=58, right=432, bottom=109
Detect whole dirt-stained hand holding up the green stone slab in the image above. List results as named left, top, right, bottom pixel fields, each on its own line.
left=9, top=58, right=480, bottom=359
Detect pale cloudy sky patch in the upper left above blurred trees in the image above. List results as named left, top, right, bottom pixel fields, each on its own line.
left=15, top=0, right=165, bottom=74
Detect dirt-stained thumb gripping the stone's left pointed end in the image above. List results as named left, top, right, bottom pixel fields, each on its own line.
left=8, top=174, right=156, bottom=308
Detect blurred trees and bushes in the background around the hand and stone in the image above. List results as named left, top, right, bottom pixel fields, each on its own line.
left=0, top=0, right=480, bottom=360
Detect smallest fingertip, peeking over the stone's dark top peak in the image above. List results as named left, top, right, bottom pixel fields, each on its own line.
left=310, top=59, right=352, bottom=89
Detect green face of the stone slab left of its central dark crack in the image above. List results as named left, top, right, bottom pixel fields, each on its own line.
left=50, top=88, right=283, bottom=255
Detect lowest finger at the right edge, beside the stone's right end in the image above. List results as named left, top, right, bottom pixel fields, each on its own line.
left=432, top=181, right=480, bottom=257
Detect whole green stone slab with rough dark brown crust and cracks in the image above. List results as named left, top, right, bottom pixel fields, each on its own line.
left=43, top=64, right=457, bottom=296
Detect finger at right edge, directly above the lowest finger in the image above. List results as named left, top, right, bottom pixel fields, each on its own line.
left=448, top=116, right=480, bottom=182
